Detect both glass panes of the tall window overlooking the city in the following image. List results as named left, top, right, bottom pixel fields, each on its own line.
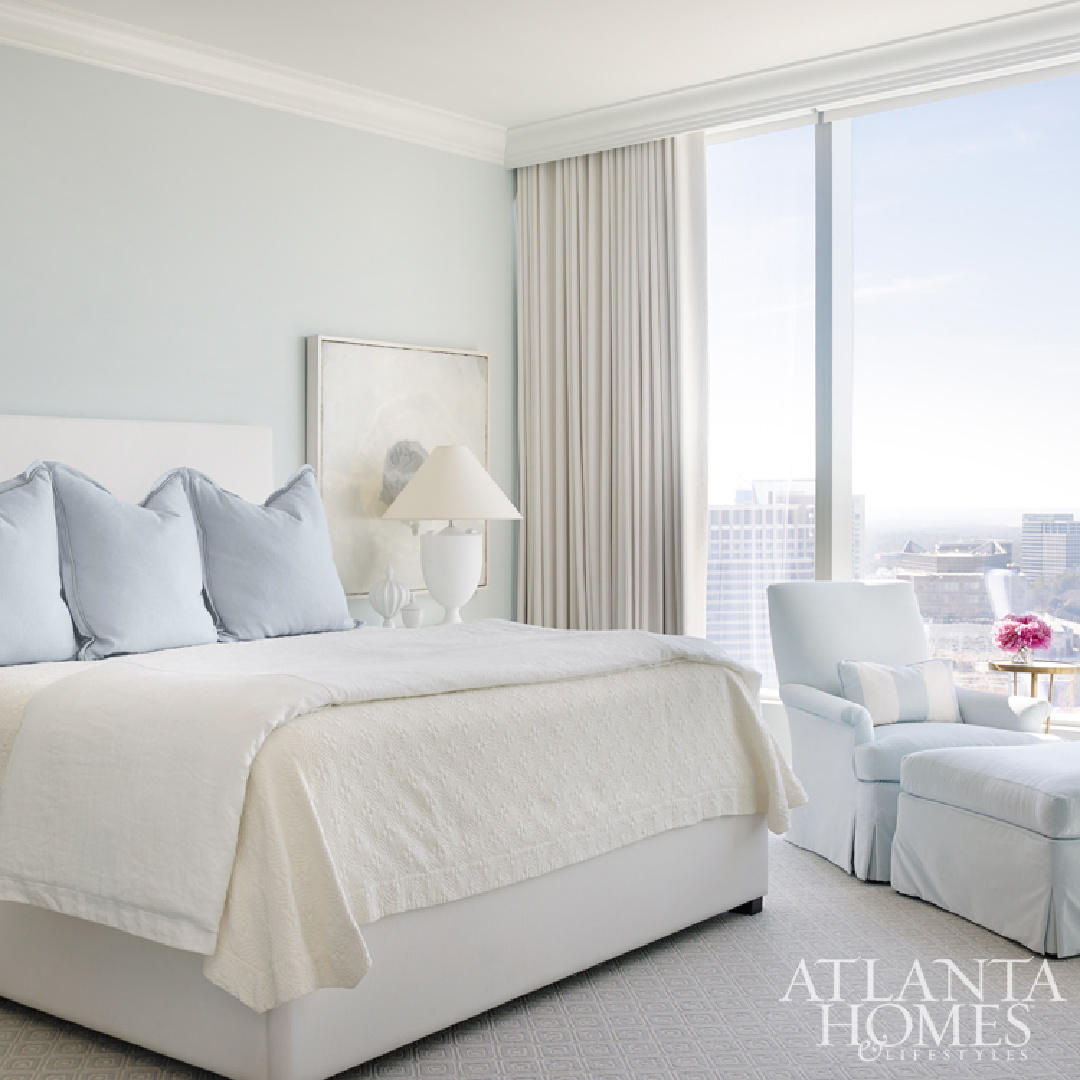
left=707, top=69, right=1080, bottom=710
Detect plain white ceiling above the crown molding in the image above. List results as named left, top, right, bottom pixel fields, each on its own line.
left=12, top=0, right=1055, bottom=129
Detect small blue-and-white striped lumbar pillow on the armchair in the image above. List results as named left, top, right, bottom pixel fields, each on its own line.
left=837, top=660, right=960, bottom=727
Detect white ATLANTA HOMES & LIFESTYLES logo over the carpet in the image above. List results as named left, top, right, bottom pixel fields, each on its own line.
left=780, top=957, right=1065, bottom=1062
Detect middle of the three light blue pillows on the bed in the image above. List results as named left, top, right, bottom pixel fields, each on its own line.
left=51, top=463, right=217, bottom=660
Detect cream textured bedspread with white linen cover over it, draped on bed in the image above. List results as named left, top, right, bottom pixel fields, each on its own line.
left=0, top=621, right=801, bottom=1009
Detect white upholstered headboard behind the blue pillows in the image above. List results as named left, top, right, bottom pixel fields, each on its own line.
left=0, top=416, right=273, bottom=502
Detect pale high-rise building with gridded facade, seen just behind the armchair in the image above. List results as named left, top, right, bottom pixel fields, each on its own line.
left=705, top=480, right=865, bottom=686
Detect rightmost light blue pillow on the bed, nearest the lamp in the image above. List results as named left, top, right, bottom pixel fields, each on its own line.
left=188, top=465, right=355, bottom=642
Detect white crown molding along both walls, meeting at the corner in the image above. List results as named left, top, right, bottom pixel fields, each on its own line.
left=0, top=0, right=1080, bottom=167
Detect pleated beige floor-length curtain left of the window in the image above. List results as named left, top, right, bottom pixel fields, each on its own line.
left=517, top=134, right=707, bottom=634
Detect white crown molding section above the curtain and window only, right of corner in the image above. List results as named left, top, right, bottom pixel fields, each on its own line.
left=505, top=0, right=1080, bottom=168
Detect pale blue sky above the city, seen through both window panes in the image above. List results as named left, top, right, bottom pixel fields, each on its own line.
left=707, top=69, right=1080, bottom=524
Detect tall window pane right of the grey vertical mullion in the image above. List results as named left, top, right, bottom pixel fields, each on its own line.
left=852, top=77, right=1080, bottom=708
